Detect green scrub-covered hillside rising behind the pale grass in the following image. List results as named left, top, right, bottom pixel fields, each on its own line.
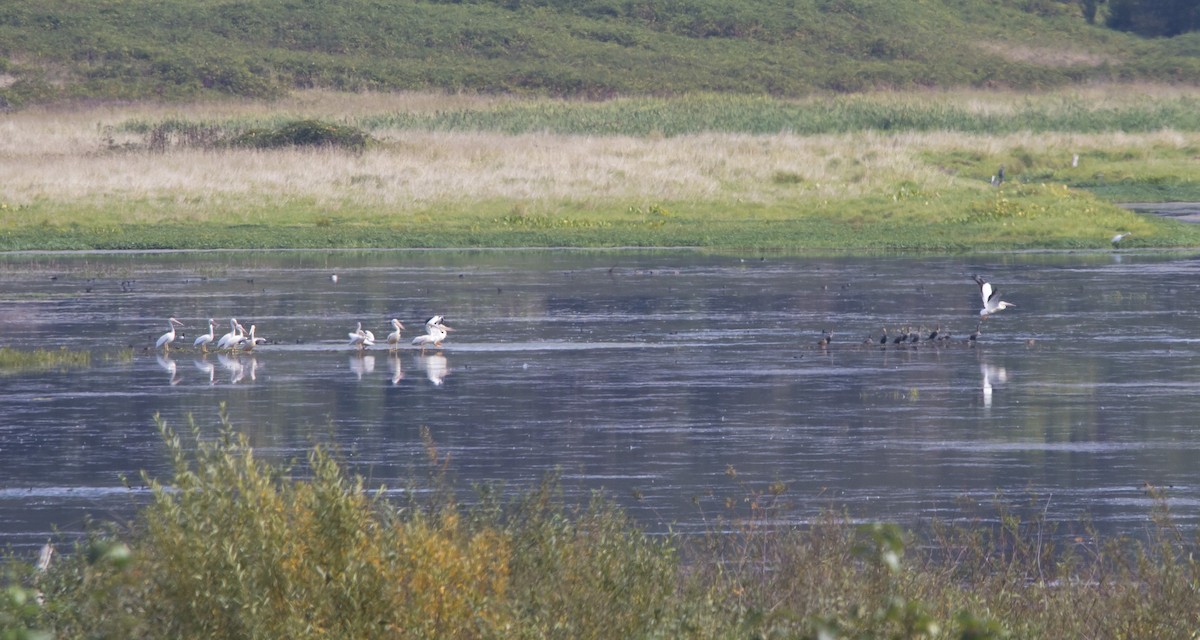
left=0, top=0, right=1200, bottom=107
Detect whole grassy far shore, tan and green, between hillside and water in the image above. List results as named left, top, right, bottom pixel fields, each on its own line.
left=0, top=85, right=1200, bottom=253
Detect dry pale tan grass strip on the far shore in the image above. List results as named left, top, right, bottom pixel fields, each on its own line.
left=7, top=89, right=1200, bottom=222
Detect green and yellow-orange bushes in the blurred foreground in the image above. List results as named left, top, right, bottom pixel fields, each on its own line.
left=0, top=410, right=1200, bottom=639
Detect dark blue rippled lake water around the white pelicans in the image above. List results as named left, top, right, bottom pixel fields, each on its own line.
left=0, top=251, right=1200, bottom=548
